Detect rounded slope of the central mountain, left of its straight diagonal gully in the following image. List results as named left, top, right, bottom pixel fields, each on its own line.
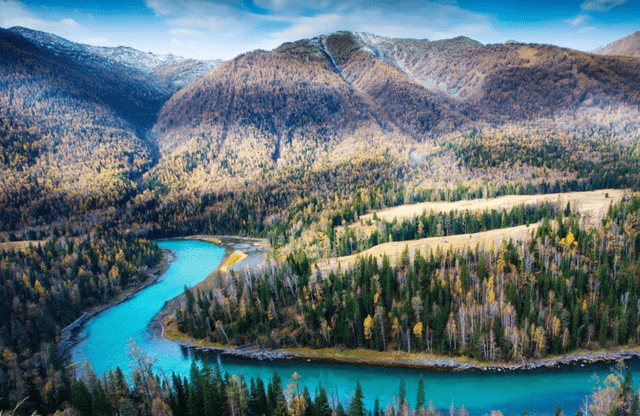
left=153, top=38, right=418, bottom=193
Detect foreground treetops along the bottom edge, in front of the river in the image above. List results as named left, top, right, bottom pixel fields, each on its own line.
left=6, top=345, right=640, bottom=416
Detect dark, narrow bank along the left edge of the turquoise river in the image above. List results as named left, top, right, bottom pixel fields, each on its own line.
left=58, top=250, right=175, bottom=355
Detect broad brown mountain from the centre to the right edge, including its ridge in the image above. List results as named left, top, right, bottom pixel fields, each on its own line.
left=149, top=32, right=640, bottom=192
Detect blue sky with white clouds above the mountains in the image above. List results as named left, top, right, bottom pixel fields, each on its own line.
left=0, top=0, right=640, bottom=59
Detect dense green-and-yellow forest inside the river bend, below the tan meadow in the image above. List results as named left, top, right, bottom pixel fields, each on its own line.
left=177, top=197, right=640, bottom=361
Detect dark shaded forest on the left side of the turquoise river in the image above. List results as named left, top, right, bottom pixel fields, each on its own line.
left=0, top=227, right=162, bottom=414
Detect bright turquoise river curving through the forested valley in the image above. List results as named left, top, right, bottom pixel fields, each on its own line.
left=71, top=240, right=640, bottom=415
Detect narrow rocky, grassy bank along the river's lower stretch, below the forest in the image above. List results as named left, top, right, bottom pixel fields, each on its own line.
left=162, top=316, right=640, bottom=372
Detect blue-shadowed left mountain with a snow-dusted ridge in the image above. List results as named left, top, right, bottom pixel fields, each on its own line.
left=0, top=28, right=217, bottom=229
